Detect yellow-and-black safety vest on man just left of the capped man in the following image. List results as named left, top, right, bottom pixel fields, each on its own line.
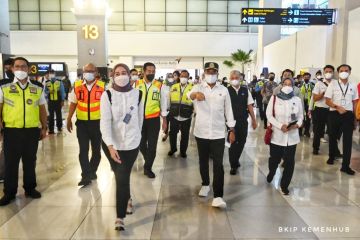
left=170, top=83, right=193, bottom=118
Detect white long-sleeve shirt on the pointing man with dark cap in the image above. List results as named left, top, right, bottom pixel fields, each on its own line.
left=188, top=82, right=236, bottom=139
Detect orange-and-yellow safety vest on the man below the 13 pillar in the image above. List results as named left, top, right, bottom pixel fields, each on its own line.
left=74, top=80, right=105, bottom=121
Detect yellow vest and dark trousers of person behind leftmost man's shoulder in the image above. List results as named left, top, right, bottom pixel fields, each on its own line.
left=45, top=79, right=65, bottom=133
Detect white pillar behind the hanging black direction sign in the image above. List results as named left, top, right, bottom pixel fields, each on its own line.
left=257, top=0, right=282, bottom=73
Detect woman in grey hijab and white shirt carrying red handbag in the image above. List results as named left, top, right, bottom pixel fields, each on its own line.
left=266, top=78, right=304, bottom=195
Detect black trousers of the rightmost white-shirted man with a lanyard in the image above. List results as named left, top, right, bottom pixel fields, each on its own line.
left=328, top=111, right=355, bottom=168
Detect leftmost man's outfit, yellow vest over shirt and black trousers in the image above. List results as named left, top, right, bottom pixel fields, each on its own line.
left=0, top=79, right=46, bottom=202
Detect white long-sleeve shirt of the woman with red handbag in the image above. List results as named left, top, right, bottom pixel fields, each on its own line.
left=266, top=96, right=304, bottom=146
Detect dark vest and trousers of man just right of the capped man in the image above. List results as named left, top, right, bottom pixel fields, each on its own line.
left=228, top=84, right=254, bottom=169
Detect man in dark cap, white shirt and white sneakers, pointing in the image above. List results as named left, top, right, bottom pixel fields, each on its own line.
left=188, top=62, right=236, bottom=208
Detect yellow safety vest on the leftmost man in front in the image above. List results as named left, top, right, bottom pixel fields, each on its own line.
left=1, top=82, right=43, bottom=128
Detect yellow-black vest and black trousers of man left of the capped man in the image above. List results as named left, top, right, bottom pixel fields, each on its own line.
left=169, top=83, right=194, bottom=158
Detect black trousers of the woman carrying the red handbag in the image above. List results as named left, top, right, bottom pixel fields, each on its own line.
left=269, top=143, right=296, bottom=189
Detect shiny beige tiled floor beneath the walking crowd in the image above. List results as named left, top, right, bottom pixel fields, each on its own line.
left=0, top=109, right=360, bottom=240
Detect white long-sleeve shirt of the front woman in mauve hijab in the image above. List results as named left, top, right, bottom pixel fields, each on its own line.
left=100, top=89, right=144, bottom=151
